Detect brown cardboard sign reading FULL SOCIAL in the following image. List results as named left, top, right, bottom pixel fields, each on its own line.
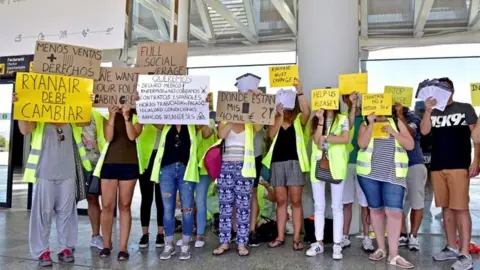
left=136, top=42, right=188, bottom=75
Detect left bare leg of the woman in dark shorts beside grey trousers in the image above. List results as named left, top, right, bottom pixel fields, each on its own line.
left=100, top=179, right=118, bottom=249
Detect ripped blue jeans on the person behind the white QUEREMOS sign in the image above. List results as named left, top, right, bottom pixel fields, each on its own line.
left=160, top=163, right=196, bottom=243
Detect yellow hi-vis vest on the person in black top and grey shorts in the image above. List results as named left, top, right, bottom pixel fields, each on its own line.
left=262, top=114, right=310, bottom=172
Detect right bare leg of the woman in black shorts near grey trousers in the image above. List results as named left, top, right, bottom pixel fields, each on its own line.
left=118, top=179, right=137, bottom=252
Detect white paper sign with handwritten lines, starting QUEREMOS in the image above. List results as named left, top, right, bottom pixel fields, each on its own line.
left=137, top=75, right=210, bottom=125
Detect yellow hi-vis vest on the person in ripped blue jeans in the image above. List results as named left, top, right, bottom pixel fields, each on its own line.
left=150, top=125, right=199, bottom=184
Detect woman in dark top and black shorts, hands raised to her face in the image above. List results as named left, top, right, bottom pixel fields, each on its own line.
left=93, top=105, right=142, bottom=261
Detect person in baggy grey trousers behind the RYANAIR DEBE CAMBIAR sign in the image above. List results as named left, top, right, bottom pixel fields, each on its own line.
left=13, top=94, right=92, bottom=267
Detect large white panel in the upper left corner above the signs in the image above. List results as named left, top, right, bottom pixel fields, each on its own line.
left=0, top=0, right=126, bottom=56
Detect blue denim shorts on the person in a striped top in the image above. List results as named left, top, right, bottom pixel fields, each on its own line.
left=357, top=175, right=405, bottom=211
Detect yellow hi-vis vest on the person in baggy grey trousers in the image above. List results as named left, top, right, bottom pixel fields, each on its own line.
left=23, top=122, right=92, bottom=184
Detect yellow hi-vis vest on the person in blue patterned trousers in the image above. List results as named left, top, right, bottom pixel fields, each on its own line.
left=198, top=124, right=257, bottom=178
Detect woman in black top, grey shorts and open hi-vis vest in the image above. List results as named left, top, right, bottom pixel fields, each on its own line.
left=263, top=82, right=310, bottom=251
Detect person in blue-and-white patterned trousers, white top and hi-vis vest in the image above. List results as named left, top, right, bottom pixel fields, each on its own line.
left=209, top=90, right=263, bottom=256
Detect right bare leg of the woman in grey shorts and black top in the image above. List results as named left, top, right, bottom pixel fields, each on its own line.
left=288, top=186, right=303, bottom=250
